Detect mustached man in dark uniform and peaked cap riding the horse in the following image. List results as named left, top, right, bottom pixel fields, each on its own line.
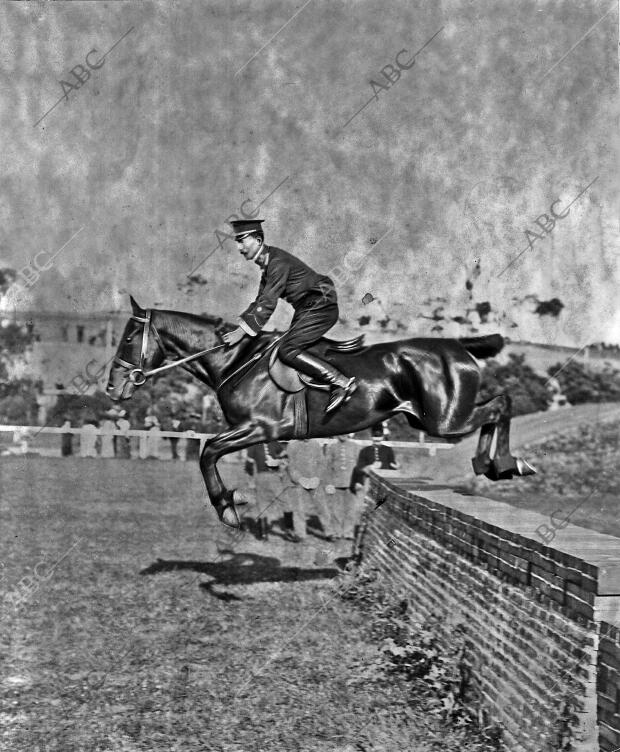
left=223, top=219, right=357, bottom=412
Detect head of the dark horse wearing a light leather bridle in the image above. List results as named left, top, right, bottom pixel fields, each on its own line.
left=106, top=296, right=165, bottom=402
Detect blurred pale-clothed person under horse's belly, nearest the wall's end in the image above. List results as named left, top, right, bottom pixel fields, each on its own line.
left=323, top=436, right=364, bottom=540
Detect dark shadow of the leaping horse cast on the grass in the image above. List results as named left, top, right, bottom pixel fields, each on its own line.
left=140, top=549, right=340, bottom=601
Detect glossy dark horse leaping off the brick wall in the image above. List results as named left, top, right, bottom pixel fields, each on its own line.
left=107, top=298, right=535, bottom=527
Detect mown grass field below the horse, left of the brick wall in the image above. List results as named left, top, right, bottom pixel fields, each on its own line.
left=0, top=458, right=494, bottom=752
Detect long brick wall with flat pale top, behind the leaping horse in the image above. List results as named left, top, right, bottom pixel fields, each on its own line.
left=360, top=475, right=620, bottom=752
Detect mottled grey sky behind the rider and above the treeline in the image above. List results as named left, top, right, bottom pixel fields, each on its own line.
left=0, top=0, right=620, bottom=345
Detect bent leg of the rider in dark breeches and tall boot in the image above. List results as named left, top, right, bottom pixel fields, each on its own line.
left=279, top=295, right=356, bottom=412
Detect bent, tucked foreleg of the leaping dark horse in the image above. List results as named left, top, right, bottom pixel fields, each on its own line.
left=200, top=421, right=268, bottom=528
